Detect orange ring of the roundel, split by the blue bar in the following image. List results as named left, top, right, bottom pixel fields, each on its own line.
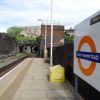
left=78, top=36, right=96, bottom=76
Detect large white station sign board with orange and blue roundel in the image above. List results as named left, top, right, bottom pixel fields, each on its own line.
left=74, top=11, right=100, bottom=92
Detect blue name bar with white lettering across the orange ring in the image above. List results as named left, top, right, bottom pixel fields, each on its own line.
left=76, top=51, right=100, bottom=63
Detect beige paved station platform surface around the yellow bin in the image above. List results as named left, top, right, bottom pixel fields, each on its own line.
left=0, top=58, right=74, bottom=100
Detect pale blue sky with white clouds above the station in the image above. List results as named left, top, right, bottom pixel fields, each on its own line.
left=0, top=0, right=100, bottom=32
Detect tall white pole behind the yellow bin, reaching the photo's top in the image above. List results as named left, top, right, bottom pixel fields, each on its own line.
left=50, top=0, right=53, bottom=67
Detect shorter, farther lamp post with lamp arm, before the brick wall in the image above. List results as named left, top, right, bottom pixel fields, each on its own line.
left=38, top=19, right=48, bottom=60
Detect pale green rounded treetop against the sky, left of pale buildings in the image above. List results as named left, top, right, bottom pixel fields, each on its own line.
left=7, top=27, right=23, bottom=38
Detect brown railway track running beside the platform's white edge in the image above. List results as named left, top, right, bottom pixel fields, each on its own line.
left=0, top=55, right=31, bottom=77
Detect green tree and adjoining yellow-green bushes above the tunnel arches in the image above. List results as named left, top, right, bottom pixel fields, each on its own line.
left=7, top=27, right=40, bottom=45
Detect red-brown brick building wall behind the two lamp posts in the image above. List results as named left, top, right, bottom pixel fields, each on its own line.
left=41, top=25, right=64, bottom=47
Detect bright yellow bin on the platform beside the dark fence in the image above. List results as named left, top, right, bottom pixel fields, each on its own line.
left=49, top=65, right=65, bottom=83
